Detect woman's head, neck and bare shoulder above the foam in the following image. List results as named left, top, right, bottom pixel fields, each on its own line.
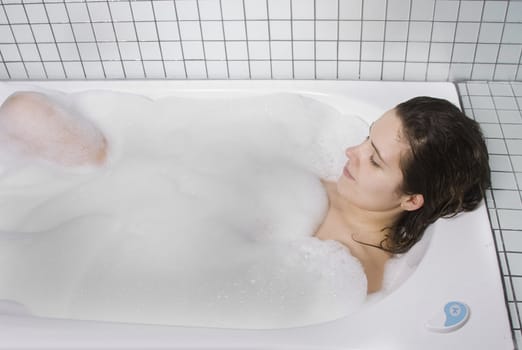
left=316, top=97, right=490, bottom=293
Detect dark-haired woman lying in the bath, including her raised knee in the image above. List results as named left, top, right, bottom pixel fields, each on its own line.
left=0, top=92, right=490, bottom=293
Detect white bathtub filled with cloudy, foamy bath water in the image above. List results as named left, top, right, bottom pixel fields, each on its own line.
left=0, top=81, right=513, bottom=349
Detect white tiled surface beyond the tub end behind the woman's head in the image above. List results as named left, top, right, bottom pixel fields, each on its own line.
left=470, top=82, right=522, bottom=340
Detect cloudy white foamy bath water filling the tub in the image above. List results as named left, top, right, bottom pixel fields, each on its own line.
left=0, top=91, right=374, bottom=328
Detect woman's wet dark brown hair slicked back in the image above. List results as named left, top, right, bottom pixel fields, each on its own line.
left=381, top=97, right=491, bottom=254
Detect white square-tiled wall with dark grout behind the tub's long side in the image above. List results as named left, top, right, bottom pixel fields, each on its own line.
left=0, top=0, right=522, bottom=80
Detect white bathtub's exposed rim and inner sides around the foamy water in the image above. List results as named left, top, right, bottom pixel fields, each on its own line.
left=0, top=81, right=513, bottom=350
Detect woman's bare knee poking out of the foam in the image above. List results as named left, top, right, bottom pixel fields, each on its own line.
left=0, top=92, right=107, bottom=166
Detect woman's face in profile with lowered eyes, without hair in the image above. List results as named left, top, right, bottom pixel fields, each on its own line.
left=337, top=109, right=410, bottom=212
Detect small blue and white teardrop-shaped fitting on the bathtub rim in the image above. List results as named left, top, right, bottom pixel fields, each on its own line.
left=426, top=301, right=470, bottom=333
